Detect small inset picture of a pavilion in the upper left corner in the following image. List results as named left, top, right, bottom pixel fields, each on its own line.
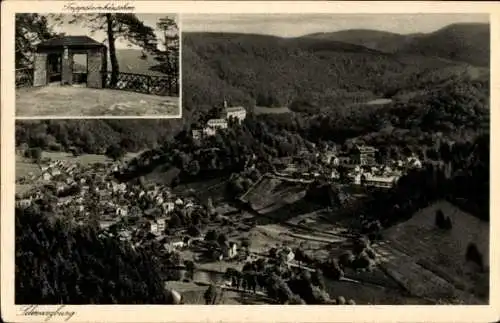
left=15, top=13, right=181, bottom=118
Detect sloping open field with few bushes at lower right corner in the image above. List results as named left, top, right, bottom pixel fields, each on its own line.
left=375, top=201, right=489, bottom=304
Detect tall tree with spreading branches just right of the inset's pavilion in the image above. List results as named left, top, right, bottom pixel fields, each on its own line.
left=55, top=13, right=157, bottom=85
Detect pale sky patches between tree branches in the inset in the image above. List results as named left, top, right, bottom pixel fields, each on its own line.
left=48, top=13, right=177, bottom=49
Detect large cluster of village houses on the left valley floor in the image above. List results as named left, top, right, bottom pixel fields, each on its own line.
left=16, top=157, right=250, bottom=266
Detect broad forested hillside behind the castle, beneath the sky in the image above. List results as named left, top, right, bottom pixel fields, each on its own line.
left=182, top=26, right=489, bottom=119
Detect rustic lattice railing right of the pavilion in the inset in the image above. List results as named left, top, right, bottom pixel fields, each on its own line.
left=104, top=72, right=179, bottom=96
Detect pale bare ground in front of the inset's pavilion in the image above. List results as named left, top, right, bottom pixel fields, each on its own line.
left=16, top=85, right=180, bottom=117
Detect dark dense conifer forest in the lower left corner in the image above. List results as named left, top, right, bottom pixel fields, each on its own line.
left=15, top=205, right=178, bottom=305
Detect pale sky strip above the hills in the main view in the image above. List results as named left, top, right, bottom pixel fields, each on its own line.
left=181, top=14, right=489, bottom=37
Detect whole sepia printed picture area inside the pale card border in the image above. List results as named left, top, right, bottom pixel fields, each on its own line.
left=15, top=13, right=490, bottom=312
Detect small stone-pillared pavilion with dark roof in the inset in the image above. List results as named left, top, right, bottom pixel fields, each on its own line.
left=33, top=36, right=107, bottom=88
